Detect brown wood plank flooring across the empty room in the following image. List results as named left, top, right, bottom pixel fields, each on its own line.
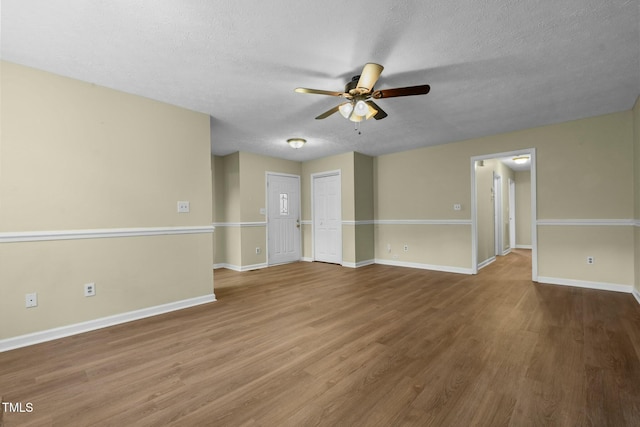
left=0, top=250, right=640, bottom=427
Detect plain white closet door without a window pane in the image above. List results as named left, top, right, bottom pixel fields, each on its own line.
left=312, top=172, right=342, bottom=264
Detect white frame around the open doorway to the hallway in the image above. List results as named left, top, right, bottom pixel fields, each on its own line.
left=470, top=148, right=538, bottom=282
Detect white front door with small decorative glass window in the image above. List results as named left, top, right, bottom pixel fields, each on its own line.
left=267, top=174, right=300, bottom=265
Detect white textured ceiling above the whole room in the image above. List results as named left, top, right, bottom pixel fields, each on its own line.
left=1, top=0, right=640, bottom=161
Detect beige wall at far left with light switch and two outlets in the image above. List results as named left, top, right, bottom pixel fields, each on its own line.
left=0, top=62, right=213, bottom=339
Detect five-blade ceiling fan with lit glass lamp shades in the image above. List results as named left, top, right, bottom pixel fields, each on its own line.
left=295, top=63, right=431, bottom=122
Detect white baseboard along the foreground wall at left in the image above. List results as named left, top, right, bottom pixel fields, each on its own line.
left=0, top=294, right=216, bottom=353
